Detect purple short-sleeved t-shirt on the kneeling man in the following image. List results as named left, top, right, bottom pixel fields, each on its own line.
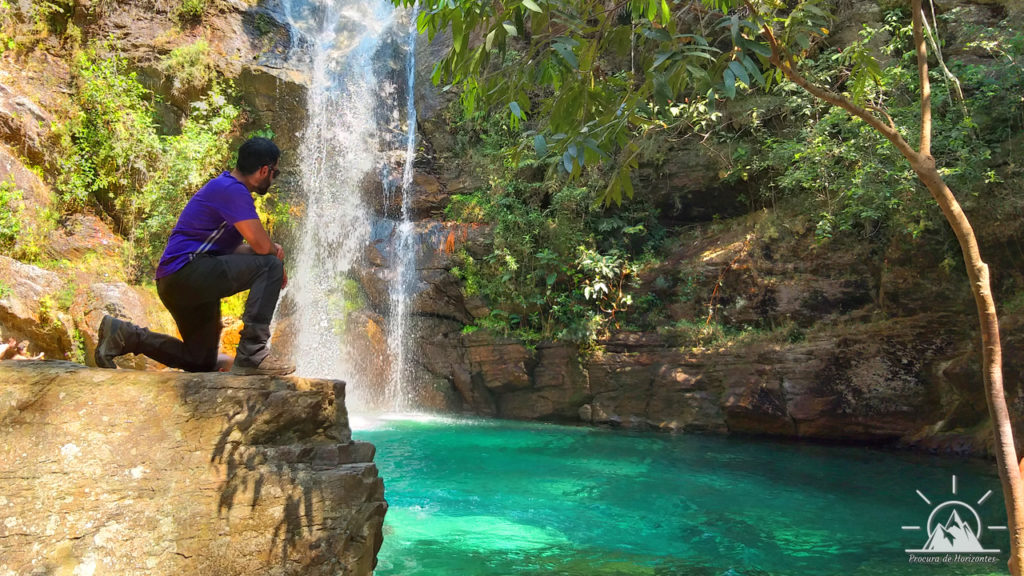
left=157, top=172, right=259, bottom=278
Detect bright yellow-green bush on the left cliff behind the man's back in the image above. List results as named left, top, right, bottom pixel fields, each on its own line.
left=57, top=45, right=240, bottom=277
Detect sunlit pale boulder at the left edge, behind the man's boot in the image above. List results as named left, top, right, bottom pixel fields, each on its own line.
left=0, top=256, right=76, bottom=360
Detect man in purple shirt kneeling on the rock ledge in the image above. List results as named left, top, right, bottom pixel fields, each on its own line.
left=94, top=138, right=295, bottom=375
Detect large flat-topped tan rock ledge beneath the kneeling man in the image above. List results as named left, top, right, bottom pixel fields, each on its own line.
left=0, top=362, right=387, bottom=576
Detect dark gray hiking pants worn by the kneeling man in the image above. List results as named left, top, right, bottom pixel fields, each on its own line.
left=131, top=254, right=285, bottom=372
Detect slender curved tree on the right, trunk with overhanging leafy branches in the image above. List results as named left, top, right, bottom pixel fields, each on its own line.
left=395, top=0, right=1024, bottom=565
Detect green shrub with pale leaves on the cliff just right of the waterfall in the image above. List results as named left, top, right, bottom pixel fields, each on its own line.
left=445, top=104, right=663, bottom=346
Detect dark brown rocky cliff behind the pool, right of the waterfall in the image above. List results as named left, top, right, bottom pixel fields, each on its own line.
left=364, top=1, right=1024, bottom=454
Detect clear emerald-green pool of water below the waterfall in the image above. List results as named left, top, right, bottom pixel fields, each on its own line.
left=353, top=414, right=1009, bottom=576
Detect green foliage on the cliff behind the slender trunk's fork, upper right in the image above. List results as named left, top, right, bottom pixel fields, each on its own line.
left=744, top=12, right=1024, bottom=238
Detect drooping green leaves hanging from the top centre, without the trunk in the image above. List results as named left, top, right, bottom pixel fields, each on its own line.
left=395, top=0, right=774, bottom=203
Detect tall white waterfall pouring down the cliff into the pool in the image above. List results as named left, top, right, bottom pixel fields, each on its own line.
left=279, top=0, right=416, bottom=410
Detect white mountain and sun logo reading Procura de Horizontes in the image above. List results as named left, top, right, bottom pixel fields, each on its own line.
left=902, top=476, right=1007, bottom=553
